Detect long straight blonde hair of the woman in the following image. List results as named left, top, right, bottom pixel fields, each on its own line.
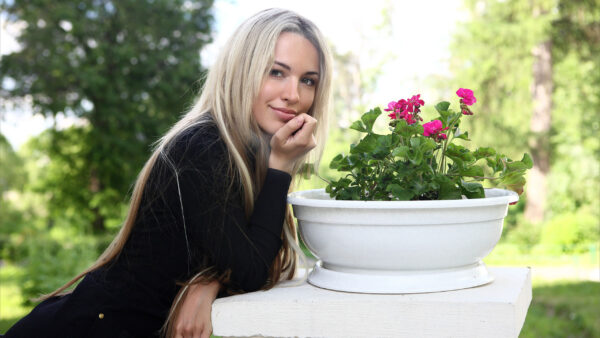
left=40, top=9, right=332, bottom=335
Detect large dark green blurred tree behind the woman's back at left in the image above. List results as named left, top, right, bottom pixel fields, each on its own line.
left=0, top=0, right=213, bottom=232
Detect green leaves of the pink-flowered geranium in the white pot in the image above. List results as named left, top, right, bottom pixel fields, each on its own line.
left=325, top=95, right=533, bottom=200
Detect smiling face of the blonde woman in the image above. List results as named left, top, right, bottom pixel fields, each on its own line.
left=252, top=32, right=319, bottom=135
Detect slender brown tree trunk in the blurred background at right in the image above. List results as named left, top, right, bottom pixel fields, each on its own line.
left=525, top=40, right=553, bottom=223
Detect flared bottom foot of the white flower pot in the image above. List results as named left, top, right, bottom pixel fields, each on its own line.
left=308, top=261, right=494, bottom=294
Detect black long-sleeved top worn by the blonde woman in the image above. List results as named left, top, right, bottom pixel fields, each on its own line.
left=6, top=121, right=291, bottom=337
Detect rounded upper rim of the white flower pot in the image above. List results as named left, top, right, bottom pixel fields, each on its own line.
left=287, top=188, right=519, bottom=209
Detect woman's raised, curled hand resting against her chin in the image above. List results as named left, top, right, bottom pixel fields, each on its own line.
left=269, top=114, right=317, bottom=174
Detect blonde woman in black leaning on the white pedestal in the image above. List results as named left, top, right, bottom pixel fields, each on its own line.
left=6, top=9, right=331, bottom=337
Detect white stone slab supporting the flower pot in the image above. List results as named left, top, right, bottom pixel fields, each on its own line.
left=212, top=268, right=531, bottom=338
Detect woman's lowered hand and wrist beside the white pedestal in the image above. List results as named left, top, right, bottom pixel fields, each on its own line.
left=174, top=281, right=221, bottom=338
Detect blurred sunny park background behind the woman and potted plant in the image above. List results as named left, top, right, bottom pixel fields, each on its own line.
left=0, top=0, right=600, bottom=337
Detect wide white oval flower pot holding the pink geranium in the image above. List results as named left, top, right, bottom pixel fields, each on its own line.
left=288, top=189, right=519, bottom=293
